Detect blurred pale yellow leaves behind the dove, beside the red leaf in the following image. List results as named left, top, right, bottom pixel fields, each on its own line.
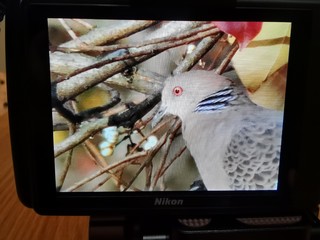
left=232, top=22, right=291, bottom=110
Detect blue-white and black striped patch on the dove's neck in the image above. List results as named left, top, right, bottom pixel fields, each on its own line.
left=194, top=87, right=238, bottom=112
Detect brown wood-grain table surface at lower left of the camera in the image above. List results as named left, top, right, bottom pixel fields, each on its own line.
left=0, top=113, right=89, bottom=240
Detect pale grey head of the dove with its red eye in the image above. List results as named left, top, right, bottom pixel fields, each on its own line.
left=155, top=70, right=231, bottom=124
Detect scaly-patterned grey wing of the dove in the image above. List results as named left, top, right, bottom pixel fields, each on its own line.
left=223, top=115, right=282, bottom=190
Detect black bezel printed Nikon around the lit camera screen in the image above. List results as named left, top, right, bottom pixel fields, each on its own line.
left=18, top=1, right=311, bottom=214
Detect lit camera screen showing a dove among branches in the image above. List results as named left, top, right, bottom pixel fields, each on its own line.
left=48, top=18, right=291, bottom=192
